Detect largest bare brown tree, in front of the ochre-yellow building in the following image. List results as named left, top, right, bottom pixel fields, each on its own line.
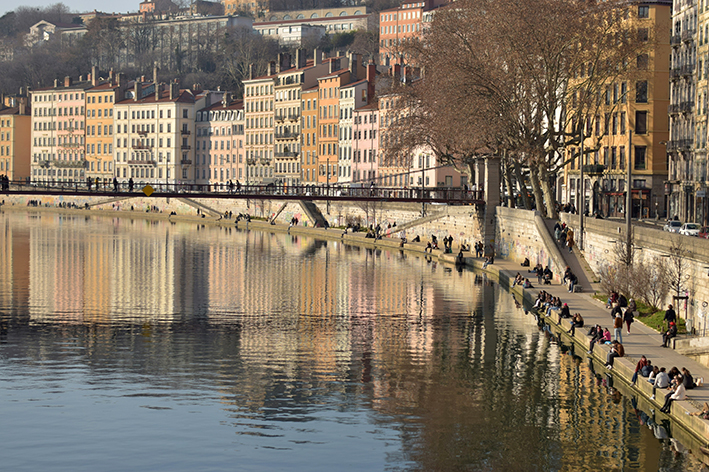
left=401, top=0, right=646, bottom=217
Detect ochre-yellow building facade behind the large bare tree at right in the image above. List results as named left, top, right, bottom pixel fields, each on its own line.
left=557, top=1, right=672, bottom=218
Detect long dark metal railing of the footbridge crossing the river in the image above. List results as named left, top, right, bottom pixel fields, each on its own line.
left=2, top=180, right=483, bottom=203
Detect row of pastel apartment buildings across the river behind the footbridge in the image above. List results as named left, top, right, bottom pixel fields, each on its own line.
left=0, top=50, right=466, bottom=191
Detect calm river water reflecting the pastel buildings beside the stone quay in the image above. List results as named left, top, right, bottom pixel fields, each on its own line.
left=0, top=212, right=698, bottom=471
